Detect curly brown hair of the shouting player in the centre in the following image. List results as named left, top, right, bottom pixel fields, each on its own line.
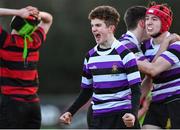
left=88, top=5, right=120, bottom=27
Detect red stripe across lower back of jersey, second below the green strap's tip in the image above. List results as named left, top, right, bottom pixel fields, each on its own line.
left=1, top=86, right=38, bottom=95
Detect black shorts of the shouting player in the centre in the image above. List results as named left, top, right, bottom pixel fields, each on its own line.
left=89, top=111, right=140, bottom=129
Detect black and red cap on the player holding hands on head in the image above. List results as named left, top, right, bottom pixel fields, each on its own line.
left=10, top=16, right=40, bottom=33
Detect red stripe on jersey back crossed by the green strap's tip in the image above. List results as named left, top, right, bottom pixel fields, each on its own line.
left=0, top=49, right=39, bottom=62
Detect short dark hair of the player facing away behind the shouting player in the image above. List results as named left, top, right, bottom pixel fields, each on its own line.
left=124, top=6, right=147, bottom=30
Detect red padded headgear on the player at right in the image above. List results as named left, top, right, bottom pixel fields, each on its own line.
left=146, top=5, right=172, bottom=33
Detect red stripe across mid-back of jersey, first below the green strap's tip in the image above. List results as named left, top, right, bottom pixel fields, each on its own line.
left=0, top=68, right=38, bottom=80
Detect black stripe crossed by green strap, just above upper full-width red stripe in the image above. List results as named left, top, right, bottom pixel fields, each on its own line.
left=4, top=46, right=39, bottom=53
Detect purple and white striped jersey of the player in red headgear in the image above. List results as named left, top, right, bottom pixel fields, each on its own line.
left=143, top=39, right=180, bottom=102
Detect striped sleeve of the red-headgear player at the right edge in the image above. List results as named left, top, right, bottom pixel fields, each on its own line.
left=160, top=41, right=180, bottom=65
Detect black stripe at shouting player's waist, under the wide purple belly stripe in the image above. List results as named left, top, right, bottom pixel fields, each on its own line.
left=93, top=86, right=129, bottom=94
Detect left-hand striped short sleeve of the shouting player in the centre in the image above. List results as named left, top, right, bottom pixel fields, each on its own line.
left=81, top=57, right=93, bottom=88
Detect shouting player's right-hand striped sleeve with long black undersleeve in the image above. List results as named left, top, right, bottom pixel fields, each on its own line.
left=123, top=49, right=141, bottom=116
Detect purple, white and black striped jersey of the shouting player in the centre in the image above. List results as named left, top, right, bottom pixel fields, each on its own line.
left=81, top=39, right=141, bottom=116
